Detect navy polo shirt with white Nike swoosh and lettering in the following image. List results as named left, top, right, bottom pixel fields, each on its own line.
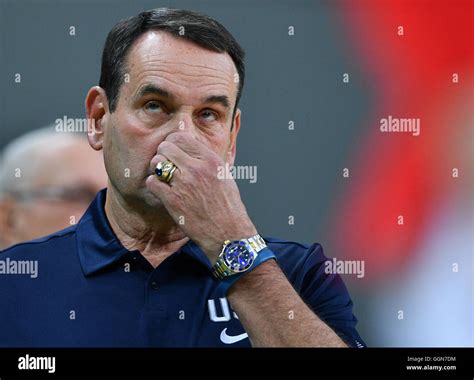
left=0, top=189, right=364, bottom=347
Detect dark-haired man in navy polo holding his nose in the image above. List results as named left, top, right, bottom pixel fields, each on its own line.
left=0, top=9, right=363, bottom=347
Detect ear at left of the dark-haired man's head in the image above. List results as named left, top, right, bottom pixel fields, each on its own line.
left=85, top=86, right=110, bottom=150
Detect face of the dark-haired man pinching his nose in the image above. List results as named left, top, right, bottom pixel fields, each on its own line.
left=102, top=32, right=240, bottom=206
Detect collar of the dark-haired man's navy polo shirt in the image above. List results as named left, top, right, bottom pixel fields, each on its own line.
left=76, top=189, right=211, bottom=276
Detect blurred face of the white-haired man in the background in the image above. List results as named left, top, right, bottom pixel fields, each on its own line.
left=0, top=139, right=107, bottom=248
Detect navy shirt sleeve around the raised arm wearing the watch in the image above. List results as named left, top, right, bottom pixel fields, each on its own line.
left=292, top=244, right=366, bottom=348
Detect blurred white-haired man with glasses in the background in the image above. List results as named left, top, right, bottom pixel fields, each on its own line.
left=0, top=126, right=107, bottom=249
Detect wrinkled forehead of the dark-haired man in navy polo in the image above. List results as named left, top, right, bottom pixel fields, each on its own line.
left=126, top=31, right=237, bottom=97
